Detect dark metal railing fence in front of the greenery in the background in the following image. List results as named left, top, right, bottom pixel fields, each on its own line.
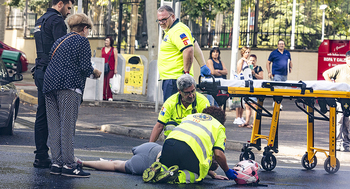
left=7, top=0, right=350, bottom=49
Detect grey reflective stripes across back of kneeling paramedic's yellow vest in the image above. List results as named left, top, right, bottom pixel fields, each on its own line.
left=174, top=120, right=215, bottom=161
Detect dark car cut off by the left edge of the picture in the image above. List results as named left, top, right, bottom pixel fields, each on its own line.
left=0, top=51, right=23, bottom=135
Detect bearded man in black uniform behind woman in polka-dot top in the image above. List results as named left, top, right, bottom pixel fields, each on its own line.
left=33, top=0, right=74, bottom=168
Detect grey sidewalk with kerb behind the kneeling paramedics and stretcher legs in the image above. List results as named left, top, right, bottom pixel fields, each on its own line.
left=15, top=65, right=350, bottom=164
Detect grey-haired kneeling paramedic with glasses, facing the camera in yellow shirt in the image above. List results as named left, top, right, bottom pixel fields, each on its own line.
left=149, top=74, right=210, bottom=142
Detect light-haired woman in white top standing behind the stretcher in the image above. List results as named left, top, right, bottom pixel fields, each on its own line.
left=233, top=47, right=250, bottom=127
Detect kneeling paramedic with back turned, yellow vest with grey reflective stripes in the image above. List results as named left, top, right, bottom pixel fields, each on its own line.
left=160, top=107, right=237, bottom=182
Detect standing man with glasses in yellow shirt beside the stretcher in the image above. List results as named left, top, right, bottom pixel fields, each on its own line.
left=157, top=5, right=210, bottom=102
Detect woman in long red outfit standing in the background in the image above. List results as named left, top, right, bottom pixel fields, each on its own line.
left=101, top=36, right=118, bottom=101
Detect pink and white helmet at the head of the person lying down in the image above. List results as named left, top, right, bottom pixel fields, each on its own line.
left=233, top=160, right=259, bottom=184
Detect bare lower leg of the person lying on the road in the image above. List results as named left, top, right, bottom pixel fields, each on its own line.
left=83, top=160, right=126, bottom=173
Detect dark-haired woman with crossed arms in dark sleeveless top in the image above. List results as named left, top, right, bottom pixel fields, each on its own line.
left=207, top=47, right=227, bottom=106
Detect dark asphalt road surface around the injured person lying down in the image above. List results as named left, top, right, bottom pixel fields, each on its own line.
left=0, top=104, right=350, bottom=189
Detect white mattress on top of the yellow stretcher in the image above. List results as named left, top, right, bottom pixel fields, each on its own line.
left=204, top=79, right=350, bottom=92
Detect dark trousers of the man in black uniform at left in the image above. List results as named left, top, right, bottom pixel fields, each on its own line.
left=34, top=69, right=49, bottom=159
